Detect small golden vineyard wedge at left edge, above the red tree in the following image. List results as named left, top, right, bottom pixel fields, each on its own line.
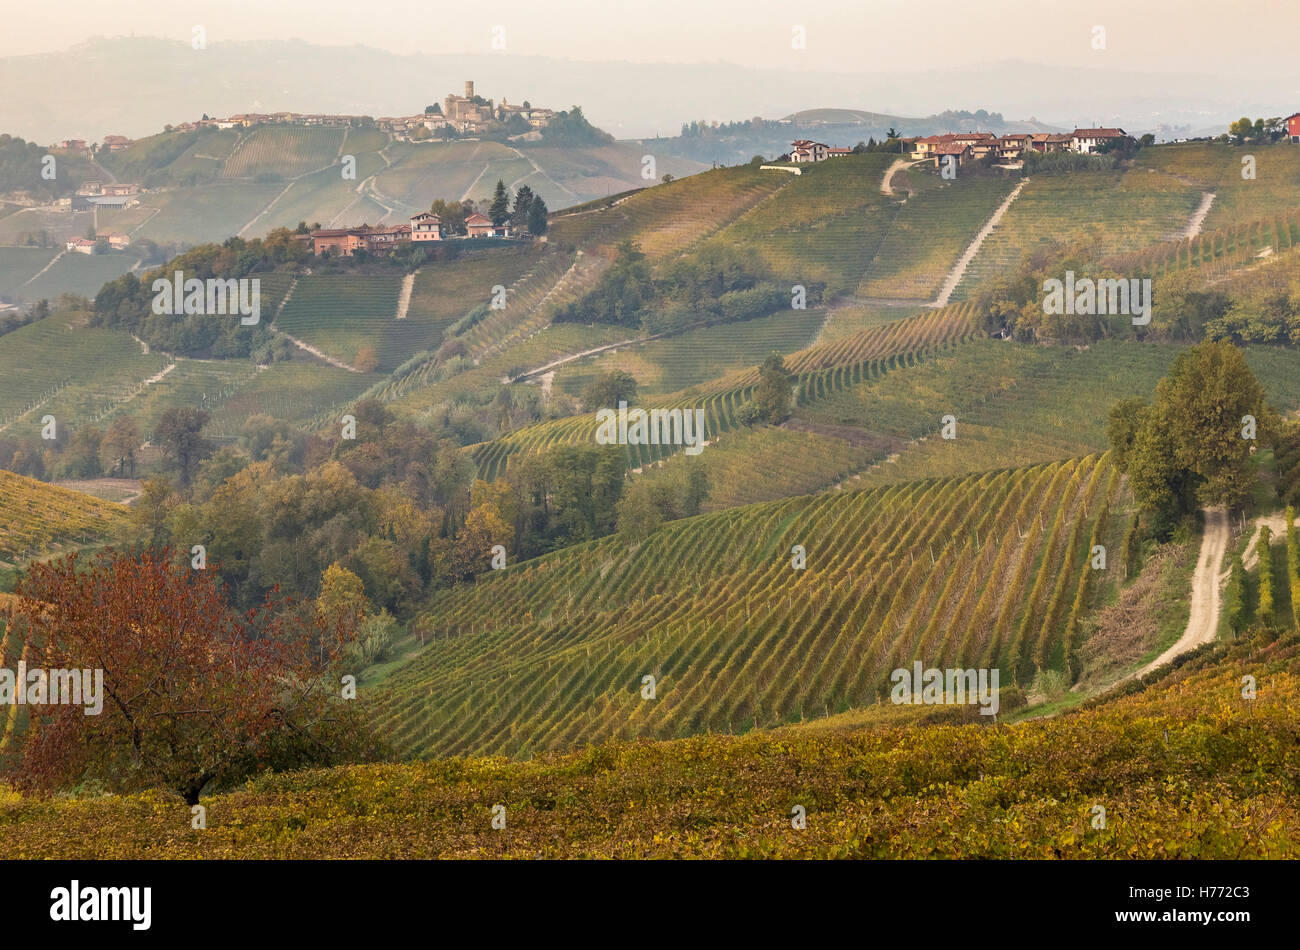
left=0, top=469, right=126, bottom=564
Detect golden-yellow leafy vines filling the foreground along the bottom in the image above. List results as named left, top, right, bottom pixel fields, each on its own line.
left=10, top=623, right=1300, bottom=860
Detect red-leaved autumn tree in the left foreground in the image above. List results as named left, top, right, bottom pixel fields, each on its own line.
left=5, top=550, right=378, bottom=804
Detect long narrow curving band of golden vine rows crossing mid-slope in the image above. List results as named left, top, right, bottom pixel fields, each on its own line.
left=471, top=307, right=972, bottom=480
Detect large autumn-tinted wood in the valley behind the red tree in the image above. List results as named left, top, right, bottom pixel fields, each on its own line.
left=119, top=400, right=707, bottom=621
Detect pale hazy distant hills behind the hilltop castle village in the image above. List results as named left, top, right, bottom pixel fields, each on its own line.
left=0, top=36, right=1300, bottom=143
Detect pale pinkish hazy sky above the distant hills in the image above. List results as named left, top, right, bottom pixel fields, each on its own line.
left=10, top=0, right=1300, bottom=75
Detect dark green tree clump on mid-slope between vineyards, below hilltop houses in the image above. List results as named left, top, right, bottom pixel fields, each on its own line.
left=555, top=240, right=824, bottom=333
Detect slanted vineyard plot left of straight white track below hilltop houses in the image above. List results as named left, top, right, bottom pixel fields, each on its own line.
left=858, top=178, right=1015, bottom=300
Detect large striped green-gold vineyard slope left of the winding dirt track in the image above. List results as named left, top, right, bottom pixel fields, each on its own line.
left=373, top=456, right=1122, bottom=756
